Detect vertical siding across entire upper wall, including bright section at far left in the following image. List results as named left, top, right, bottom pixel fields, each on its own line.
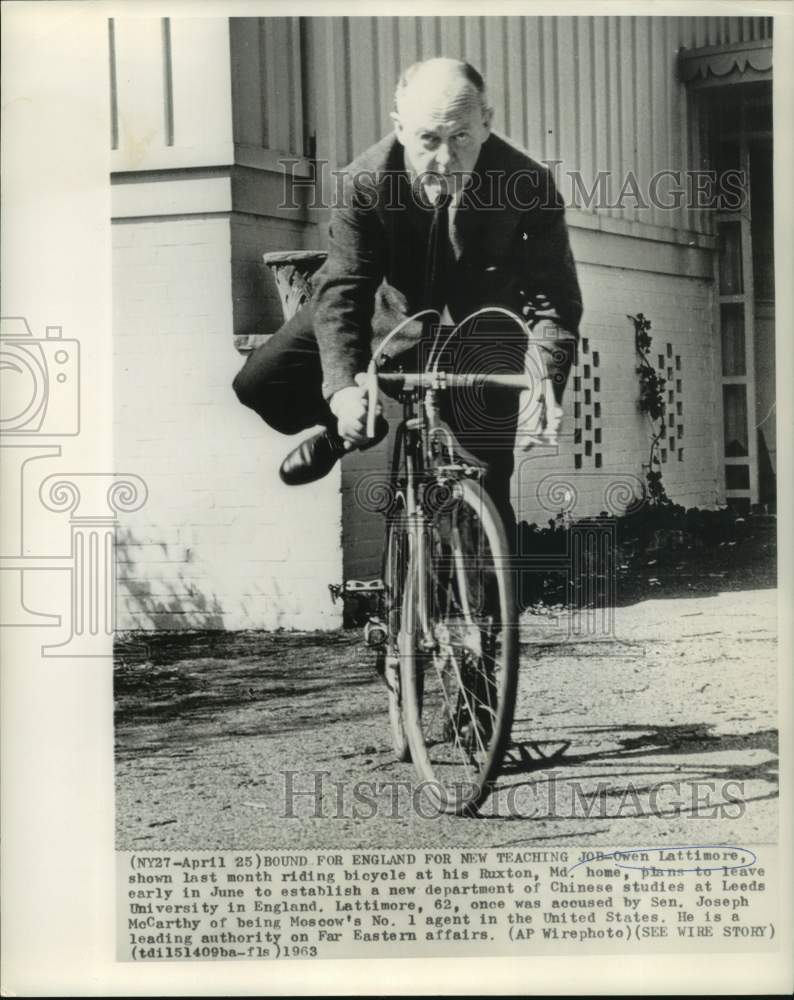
left=109, top=16, right=771, bottom=189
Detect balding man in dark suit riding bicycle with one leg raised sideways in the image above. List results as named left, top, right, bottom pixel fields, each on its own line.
left=234, top=58, right=582, bottom=519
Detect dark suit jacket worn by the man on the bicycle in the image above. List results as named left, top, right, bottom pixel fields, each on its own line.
left=311, top=135, right=582, bottom=398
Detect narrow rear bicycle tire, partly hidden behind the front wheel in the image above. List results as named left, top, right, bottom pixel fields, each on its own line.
left=382, top=493, right=411, bottom=763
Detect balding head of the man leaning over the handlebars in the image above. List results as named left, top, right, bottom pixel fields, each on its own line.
left=392, top=58, right=492, bottom=189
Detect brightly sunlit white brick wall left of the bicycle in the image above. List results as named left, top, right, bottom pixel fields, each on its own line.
left=113, top=217, right=341, bottom=629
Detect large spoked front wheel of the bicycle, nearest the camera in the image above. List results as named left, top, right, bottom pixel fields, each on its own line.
left=400, top=480, right=518, bottom=814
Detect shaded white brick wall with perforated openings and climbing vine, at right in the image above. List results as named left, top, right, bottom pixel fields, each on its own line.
left=513, top=258, right=724, bottom=524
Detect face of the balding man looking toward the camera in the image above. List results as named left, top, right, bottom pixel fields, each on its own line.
left=392, top=80, right=492, bottom=193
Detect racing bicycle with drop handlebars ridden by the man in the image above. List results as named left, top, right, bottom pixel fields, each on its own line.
left=366, top=309, right=544, bottom=815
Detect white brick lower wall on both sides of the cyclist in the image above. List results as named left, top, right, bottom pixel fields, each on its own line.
left=113, top=213, right=723, bottom=629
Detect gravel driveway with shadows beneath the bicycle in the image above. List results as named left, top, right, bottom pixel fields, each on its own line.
left=116, top=574, right=777, bottom=850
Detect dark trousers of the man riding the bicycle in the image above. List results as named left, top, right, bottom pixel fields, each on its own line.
left=234, top=311, right=526, bottom=544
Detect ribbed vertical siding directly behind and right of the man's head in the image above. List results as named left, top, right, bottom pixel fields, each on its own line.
left=310, top=16, right=771, bottom=229
